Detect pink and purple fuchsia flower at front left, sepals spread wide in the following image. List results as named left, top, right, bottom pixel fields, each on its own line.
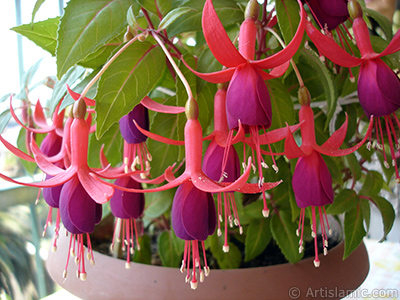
left=0, top=91, right=144, bottom=280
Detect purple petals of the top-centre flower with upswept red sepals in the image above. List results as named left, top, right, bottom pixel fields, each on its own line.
left=226, top=64, right=272, bottom=129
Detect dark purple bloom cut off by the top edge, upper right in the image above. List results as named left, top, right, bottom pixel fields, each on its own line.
left=301, top=0, right=349, bottom=31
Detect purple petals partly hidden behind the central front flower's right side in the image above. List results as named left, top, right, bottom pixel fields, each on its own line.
left=203, top=140, right=240, bottom=182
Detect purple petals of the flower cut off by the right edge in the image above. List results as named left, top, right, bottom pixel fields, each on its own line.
left=358, top=58, right=400, bottom=117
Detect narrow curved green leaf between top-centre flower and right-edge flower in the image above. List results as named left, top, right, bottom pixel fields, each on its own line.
left=300, top=48, right=338, bottom=127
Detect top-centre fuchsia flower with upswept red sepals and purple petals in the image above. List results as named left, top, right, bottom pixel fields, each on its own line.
left=181, top=0, right=306, bottom=216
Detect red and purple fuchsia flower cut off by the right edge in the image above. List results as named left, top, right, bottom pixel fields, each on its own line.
left=306, top=0, right=400, bottom=182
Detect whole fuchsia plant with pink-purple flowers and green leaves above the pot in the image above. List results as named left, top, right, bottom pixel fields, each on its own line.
left=0, top=0, right=400, bottom=298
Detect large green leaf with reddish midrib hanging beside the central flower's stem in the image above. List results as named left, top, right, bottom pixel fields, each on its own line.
left=96, top=42, right=165, bottom=138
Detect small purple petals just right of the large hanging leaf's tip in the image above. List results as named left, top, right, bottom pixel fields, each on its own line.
left=119, top=103, right=149, bottom=144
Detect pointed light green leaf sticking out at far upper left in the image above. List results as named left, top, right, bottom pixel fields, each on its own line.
left=11, top=17, right=60, bottom=56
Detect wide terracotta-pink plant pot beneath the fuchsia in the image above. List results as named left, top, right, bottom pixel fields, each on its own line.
left=47, top=234, right=369, bottom=300
